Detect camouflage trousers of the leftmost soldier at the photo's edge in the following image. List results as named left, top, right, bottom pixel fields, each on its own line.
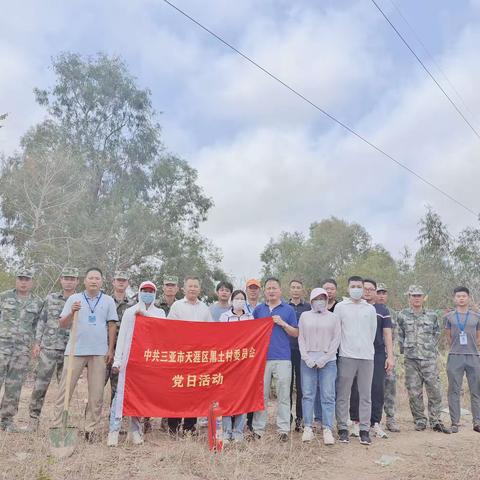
left=0, top=347, right=30, bottom=424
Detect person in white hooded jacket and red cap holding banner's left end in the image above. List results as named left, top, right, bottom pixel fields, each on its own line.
left=107, top=281, right=165, bottom=447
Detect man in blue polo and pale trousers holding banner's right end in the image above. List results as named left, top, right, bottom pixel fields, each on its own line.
left=253, top=277, right=298, bottom=442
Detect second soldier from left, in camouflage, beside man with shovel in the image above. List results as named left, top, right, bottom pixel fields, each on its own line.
left=29, top=267, right=78, bottom=431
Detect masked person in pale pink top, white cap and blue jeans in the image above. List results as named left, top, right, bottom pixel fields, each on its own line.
left=298, top=288, right=341, bottom=445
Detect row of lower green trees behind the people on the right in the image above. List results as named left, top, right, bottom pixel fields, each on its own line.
left=261, top=208, right=480, bottom=310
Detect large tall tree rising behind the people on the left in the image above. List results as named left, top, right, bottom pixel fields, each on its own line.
left=0, top=53, right=222, bottom=290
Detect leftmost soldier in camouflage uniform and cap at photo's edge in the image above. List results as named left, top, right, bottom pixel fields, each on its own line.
left=0, top=269, right=43, bottom=433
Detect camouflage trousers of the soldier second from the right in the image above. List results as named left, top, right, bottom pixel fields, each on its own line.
left=405, top=358, right=442, bottom=426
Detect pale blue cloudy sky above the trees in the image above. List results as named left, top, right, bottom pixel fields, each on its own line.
left=0, top=0, right=480, bottom=281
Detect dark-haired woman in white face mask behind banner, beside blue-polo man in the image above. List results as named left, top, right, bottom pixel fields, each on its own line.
left=220, top=290, right=253, bottom=442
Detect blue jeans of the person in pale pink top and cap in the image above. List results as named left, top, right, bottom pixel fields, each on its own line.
left=301, top=360, right=337, bottom=430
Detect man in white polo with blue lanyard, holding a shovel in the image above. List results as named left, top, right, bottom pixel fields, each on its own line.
left=53, top=268, right=118, bottom=442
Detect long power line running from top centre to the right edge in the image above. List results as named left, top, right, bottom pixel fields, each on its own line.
left=163, top=0, right=479, bottom=218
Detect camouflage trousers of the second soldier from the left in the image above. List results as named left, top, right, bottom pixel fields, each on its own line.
left=29, top=348, right=65, bottom=418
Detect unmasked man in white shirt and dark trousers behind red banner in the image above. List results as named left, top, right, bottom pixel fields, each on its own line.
left=168, top=277, right=213, bottom=438
